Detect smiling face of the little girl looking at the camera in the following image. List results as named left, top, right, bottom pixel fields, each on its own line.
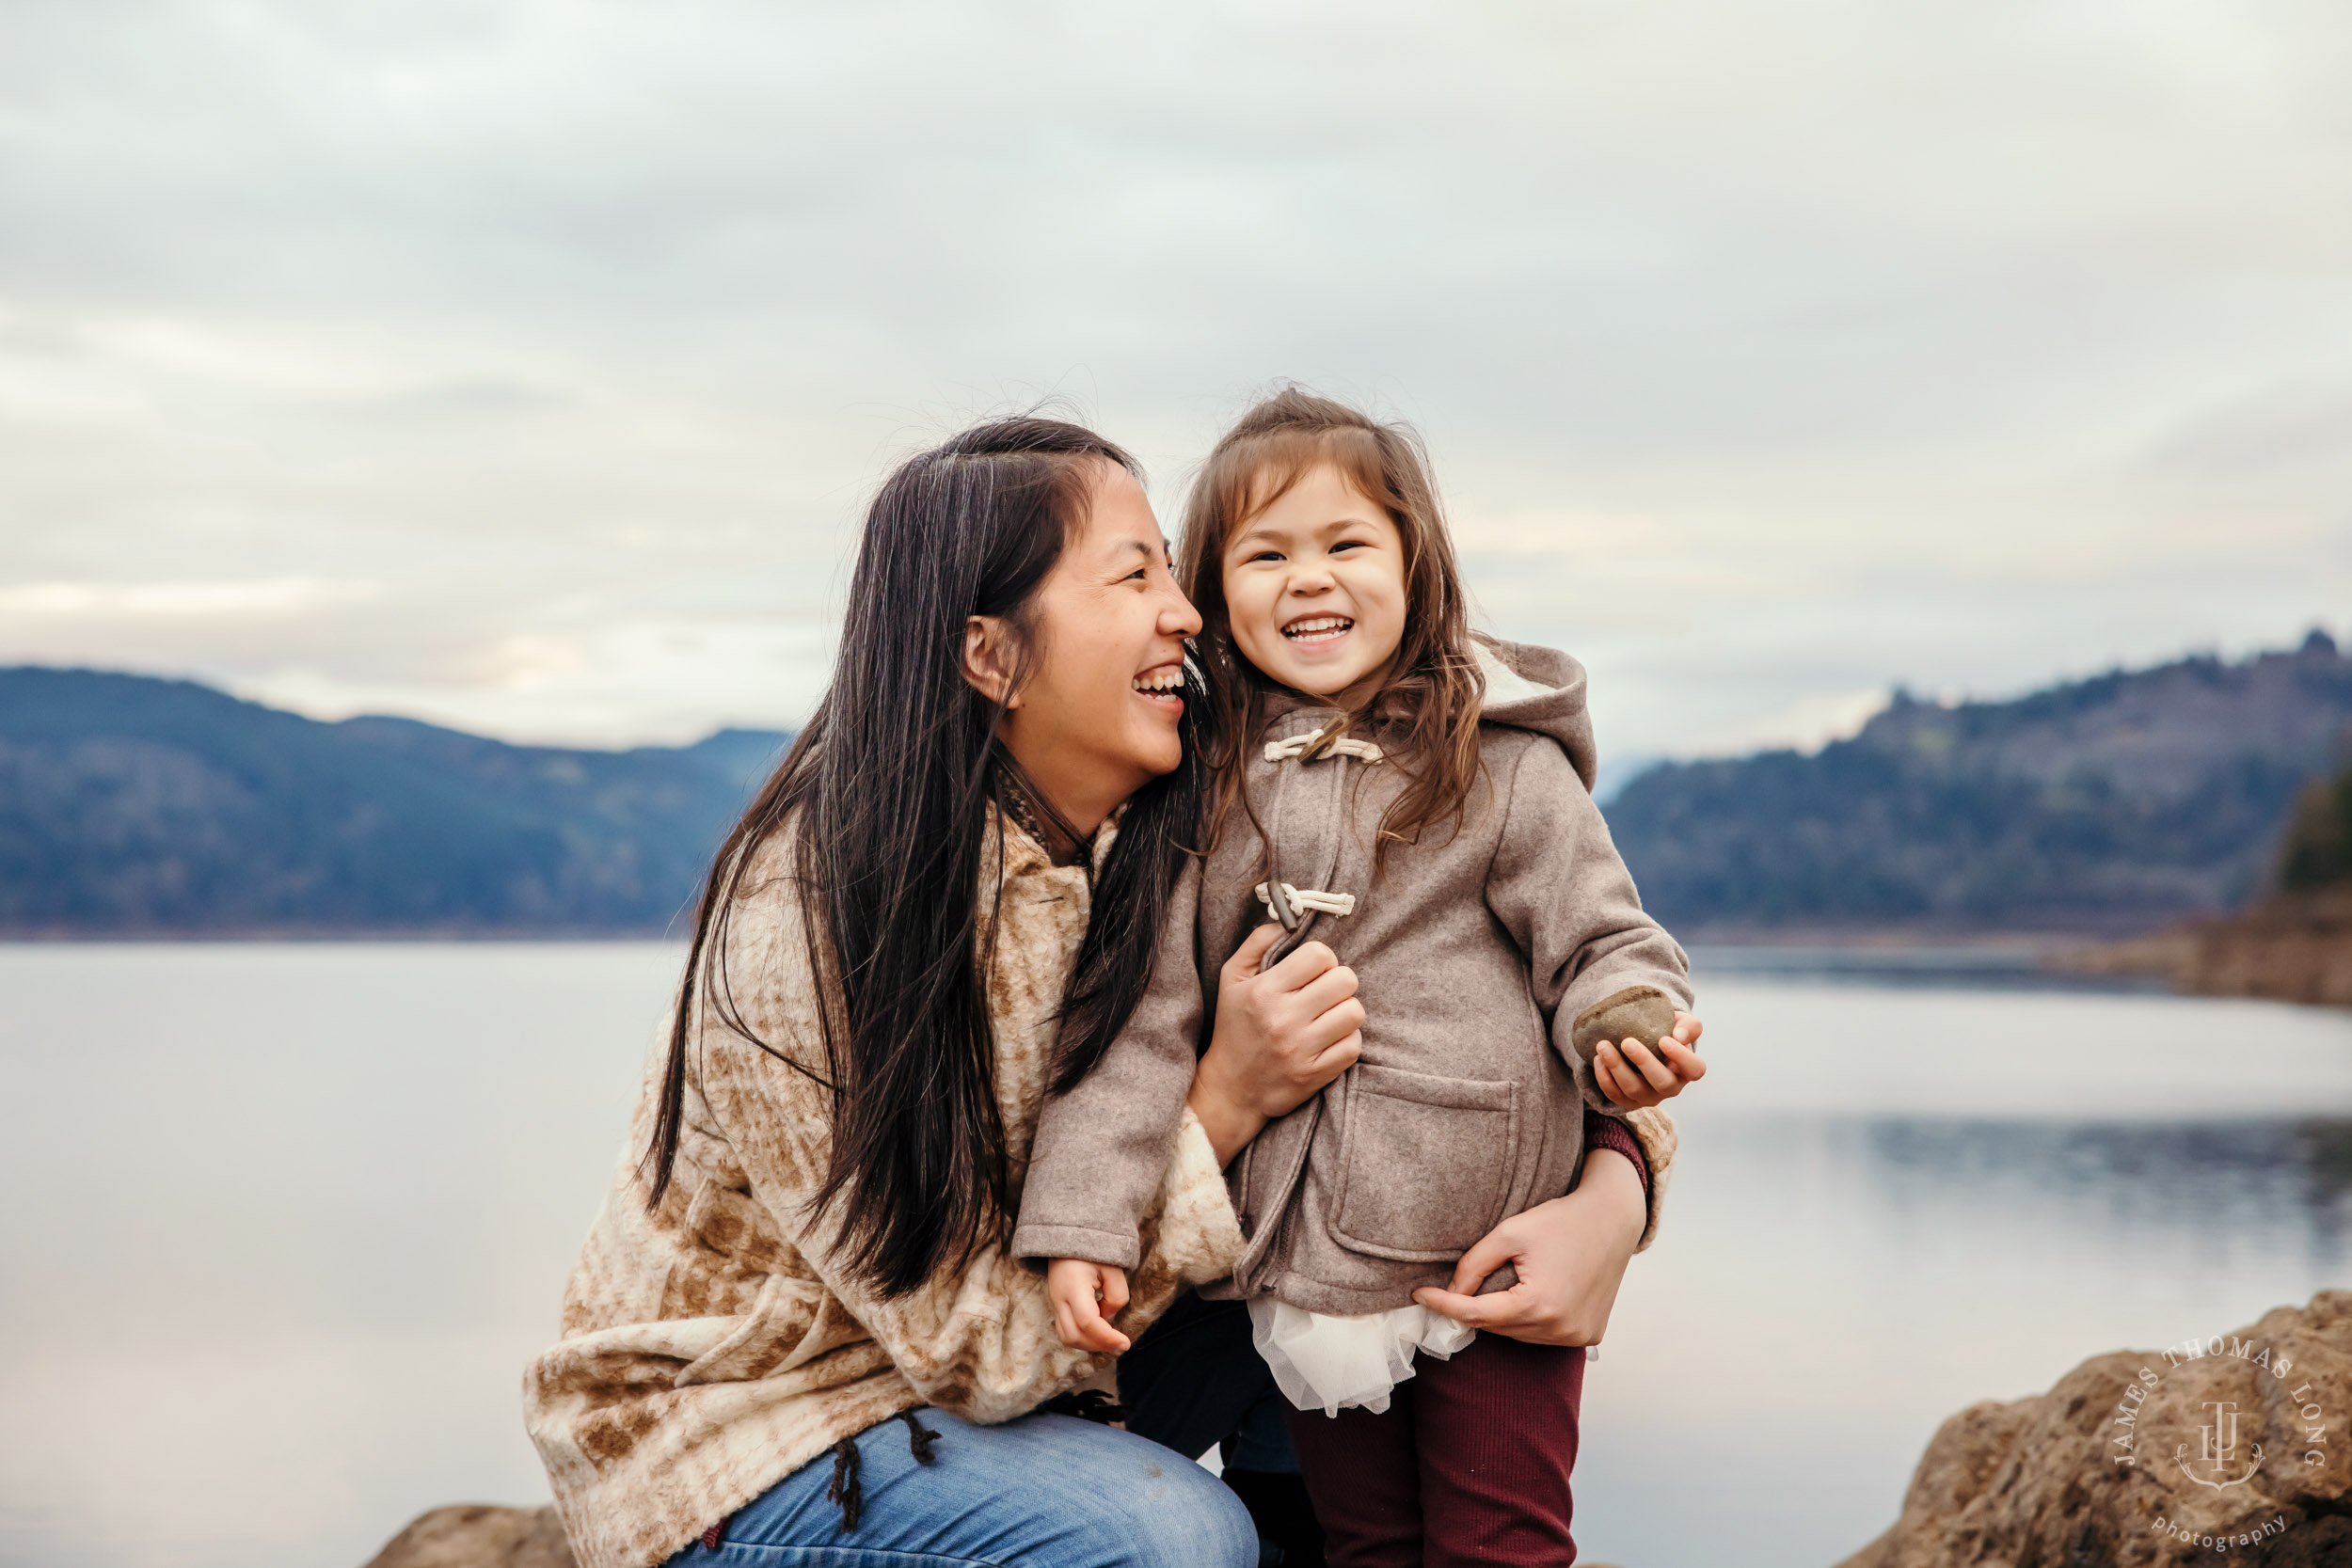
left=1223, top=463, right=1405, bottom=710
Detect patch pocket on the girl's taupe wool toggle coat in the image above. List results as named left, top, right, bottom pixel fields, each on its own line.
left=1331, top=1065, right=1519, bottom=1262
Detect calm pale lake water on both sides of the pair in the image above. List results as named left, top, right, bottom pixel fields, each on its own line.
left=0, top=942, right=2352, bottom=1568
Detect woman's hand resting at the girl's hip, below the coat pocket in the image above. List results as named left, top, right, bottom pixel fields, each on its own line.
left=1414, top=1142, right=1646, bottom=1345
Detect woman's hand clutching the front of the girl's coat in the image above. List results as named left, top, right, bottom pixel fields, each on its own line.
left=1188, top=927, right=1364, bottom=1166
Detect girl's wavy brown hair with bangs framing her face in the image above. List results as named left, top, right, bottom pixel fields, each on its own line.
left=1176, top=386, right=1486, bottom=865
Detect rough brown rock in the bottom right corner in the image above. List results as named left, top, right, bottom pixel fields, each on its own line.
left=1839, top=1291, right=2352, bottom=1568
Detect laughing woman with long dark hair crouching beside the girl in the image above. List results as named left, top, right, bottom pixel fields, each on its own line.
left=525, top=419, right=1670, bottom=1568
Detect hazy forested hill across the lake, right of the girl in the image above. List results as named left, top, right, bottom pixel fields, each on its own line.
left=1609, top=632, right=2352, bottom=931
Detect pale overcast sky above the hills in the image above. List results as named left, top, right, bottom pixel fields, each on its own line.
left=0, top=0, right=2352, bottom=754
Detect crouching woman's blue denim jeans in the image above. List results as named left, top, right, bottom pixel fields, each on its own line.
left=671, top=1411, right=1259, bottom=1568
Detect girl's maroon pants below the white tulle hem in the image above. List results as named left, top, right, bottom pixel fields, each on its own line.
left=1287, top=1333, right=1585, bottom=1568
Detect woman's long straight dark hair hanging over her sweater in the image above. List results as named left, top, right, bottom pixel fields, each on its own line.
left=644, top=419, right=1202, bottom=1295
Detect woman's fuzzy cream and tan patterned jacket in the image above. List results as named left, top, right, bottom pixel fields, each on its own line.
left=522, top=828, right=1675, bottom=1568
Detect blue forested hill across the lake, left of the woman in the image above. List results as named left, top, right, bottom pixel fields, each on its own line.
left=0, top=668, right=788, bottom=936
